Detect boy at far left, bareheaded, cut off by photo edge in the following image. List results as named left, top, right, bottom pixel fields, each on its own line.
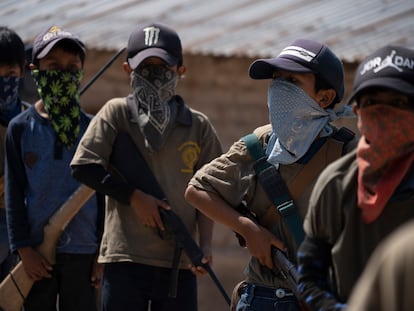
left=0, top=26, right=28, bottom=282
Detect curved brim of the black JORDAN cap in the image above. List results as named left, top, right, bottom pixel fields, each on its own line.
left=346, top=77, right=414, bottom=105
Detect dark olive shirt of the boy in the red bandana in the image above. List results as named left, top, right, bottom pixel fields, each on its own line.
left=304, top=151, right=414, bottom=301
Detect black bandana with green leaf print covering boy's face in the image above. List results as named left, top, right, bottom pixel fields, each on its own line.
left=32, top=70, right=83, bottom=148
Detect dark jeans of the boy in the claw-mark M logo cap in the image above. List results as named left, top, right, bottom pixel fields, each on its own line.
left=102, top=262, right=197, bottom=311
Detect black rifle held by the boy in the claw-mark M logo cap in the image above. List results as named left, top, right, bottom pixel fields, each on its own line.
left=110, top=133, right=230, bottom=305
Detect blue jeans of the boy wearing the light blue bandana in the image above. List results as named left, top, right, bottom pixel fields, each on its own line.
left=236, top=284, right=301, bottom=311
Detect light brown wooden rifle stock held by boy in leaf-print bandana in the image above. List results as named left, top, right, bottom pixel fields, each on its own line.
left=0, top=185, right=95, bottom=311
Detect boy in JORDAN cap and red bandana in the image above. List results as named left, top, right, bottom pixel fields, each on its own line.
left=298, top=46, right=414, bottom=310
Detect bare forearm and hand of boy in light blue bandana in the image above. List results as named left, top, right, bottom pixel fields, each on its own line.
left=185, top=185, right=284, bottom=269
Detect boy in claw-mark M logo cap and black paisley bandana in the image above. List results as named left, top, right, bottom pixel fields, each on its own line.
left=71, top=23, right=221, bottom=311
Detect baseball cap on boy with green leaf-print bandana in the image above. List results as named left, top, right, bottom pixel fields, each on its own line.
left=32, top=25, right=85, bottom=61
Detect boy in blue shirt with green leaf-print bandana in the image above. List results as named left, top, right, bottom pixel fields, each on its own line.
left=5, top=26, right=101, bottom=311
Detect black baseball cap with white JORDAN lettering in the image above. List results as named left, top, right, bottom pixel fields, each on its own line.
left=348, top=45, right=414, bottom=104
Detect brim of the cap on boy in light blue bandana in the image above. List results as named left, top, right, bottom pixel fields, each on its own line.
left=249, top=57, right=313, bottom=79
